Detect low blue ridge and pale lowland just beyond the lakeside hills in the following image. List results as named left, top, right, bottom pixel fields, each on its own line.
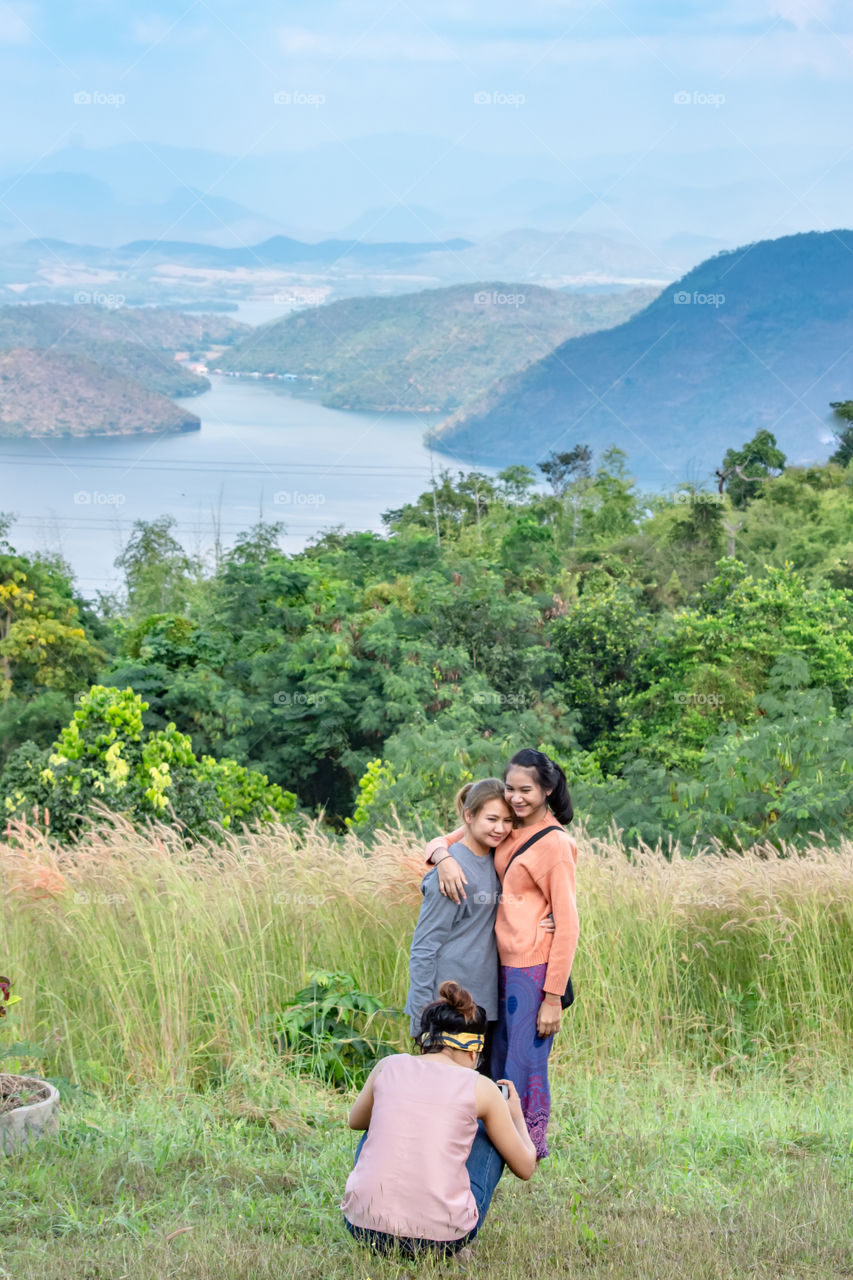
left=0, top=228, right=676, bottom=319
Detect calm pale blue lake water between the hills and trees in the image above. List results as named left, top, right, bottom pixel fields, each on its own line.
left=0, top=375, right=471, bottom=598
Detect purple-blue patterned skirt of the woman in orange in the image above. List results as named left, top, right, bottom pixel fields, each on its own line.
left=492, top=964, right=553, bottom=1160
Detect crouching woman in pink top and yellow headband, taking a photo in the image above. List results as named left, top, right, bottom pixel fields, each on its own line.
left=341, top=982, right=537, bottom=1257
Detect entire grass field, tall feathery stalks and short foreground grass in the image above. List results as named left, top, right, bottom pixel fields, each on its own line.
left=0, top=822, right=853, bottom=1280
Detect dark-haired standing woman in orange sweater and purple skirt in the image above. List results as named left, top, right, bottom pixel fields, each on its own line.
left=428, top=749, right=579, bottom=1160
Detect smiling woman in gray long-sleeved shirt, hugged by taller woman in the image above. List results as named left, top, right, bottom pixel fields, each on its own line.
left=406, top=778, right=512, bottom=1074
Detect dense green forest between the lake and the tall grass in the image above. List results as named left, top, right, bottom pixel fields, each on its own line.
left=0, top=419, right=853, bottom=846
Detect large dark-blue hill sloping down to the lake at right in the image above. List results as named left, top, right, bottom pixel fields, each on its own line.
left=434, top=230, right=853, bottom=486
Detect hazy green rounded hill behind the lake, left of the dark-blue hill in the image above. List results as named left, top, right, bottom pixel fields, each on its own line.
left=213, top=283, right=657, bottom=412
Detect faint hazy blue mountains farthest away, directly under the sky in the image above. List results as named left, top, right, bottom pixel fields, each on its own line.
left=6, top=136, right=850, bottom=250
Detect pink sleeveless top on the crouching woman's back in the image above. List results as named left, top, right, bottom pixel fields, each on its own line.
left=341, top=1053, right=478, bottom=1240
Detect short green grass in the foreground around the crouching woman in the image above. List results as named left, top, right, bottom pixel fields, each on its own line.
left=0, top=1069, right=853, bottom=1280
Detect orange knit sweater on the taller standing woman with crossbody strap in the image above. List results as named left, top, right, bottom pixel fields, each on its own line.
left=427, top=814, right=580, bottom=996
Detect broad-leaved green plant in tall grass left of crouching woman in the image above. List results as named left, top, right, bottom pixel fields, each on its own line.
left=272, top=972, right=398, bottom=1088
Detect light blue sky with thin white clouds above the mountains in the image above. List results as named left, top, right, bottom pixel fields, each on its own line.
left=0, top=0, right=853, bottom=168
